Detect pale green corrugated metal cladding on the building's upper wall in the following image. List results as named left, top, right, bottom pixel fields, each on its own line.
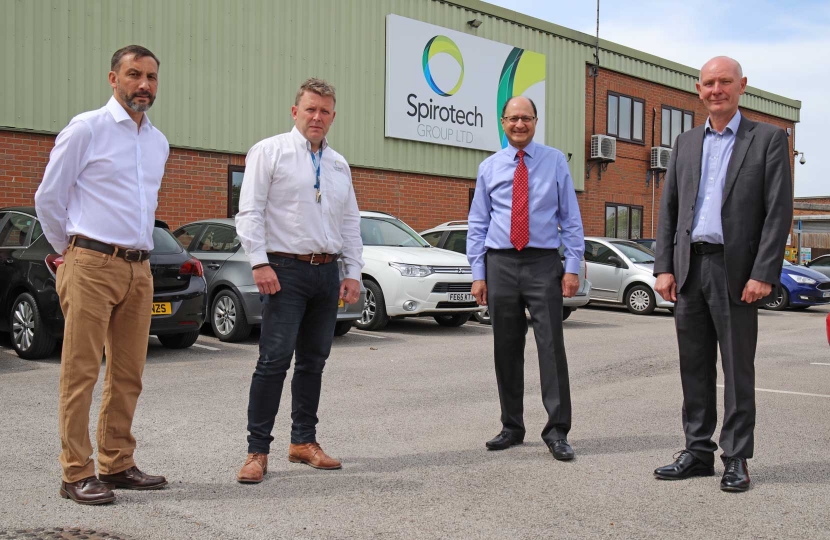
left=0, top=0, right=800, bottom=189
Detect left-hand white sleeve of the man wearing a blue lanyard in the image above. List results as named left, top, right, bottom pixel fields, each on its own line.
left=236, top=143, right=277, bottom=267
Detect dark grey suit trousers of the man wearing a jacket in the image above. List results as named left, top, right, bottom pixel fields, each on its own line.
left=674, top=252, right=758, bottom=465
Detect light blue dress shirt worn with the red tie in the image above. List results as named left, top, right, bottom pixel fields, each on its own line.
left=467, top=142, right=585, bottom=280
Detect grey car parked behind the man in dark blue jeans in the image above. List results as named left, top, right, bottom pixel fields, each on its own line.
left=173, top=218, right=365, bottom=341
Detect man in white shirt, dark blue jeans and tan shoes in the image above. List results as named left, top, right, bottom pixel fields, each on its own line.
left=236, top=79, right=363, bottom=484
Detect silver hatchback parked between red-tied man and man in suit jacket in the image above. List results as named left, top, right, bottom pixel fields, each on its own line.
left=585, top=237, right=674, bottom=315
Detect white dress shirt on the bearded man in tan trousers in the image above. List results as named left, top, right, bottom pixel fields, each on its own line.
left=35, top=97, right=170, bottom=253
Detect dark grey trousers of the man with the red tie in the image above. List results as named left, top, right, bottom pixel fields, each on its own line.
left=486, top=248, right=571, bottom=444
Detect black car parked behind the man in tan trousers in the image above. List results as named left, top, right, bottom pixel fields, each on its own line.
left=0, top=207, right=206, bottom=359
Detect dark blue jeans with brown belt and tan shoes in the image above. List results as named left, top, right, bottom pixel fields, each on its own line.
left=248, top=255, right=340, bottom=454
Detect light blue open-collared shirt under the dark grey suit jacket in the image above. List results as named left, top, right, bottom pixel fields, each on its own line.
left=692, top=111, right=741, bottom=244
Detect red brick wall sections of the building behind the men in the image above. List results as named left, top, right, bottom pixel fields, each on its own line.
left=0, top=70, right=794, bottom=237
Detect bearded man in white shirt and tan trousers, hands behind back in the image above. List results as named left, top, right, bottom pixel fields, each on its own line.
left=35, top=45, right=170, bottom=504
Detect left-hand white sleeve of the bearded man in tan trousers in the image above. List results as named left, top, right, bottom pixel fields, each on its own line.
left=35, top=120, right=92, bottom=253
